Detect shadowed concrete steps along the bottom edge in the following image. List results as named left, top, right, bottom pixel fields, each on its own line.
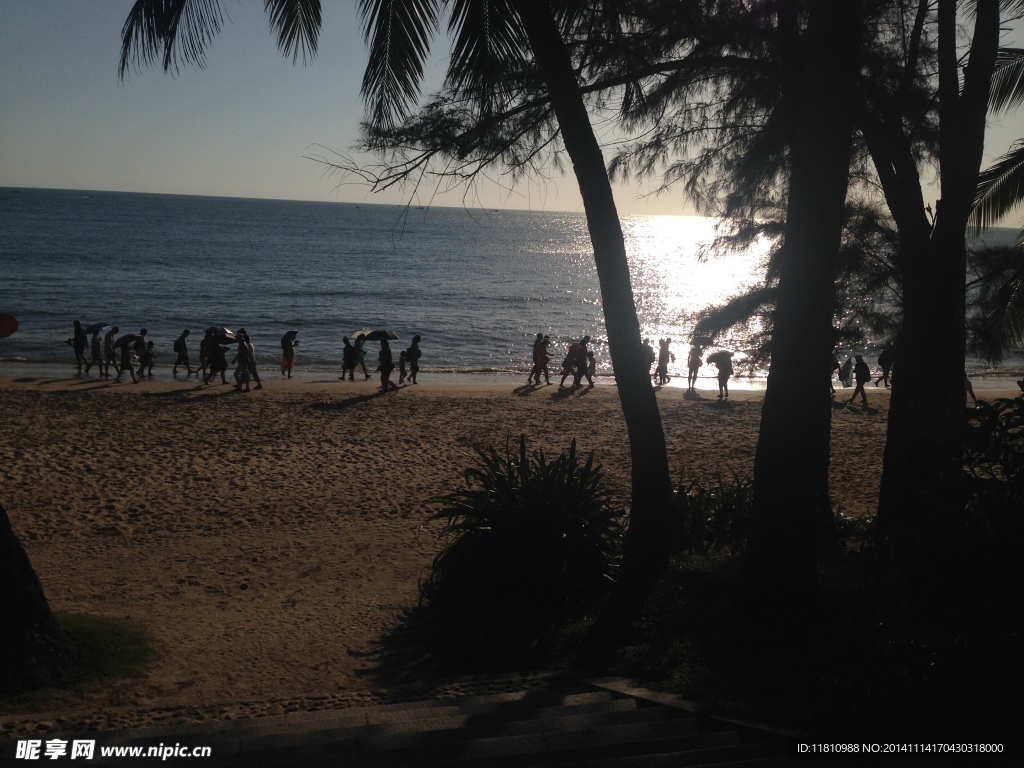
left=28, top=685, right=785, bottom=768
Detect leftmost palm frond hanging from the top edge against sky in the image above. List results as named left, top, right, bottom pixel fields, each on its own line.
left=118, top=0, right=223, bottom=79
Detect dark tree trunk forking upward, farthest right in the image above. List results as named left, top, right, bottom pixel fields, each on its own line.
left=879, top=0, right=999, bottom=547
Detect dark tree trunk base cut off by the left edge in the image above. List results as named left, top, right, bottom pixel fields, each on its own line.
left=0, top=506, right=70, bottom=693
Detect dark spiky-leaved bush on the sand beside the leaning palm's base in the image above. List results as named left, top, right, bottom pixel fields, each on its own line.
left=421, top=435, right=623, bottom=630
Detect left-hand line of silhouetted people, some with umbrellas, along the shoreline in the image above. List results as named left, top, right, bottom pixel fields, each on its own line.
left=68, top=321, right=421, bottom=392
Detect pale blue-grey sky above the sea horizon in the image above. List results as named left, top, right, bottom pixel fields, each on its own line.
left=0, top=0, right=1024, bottom=219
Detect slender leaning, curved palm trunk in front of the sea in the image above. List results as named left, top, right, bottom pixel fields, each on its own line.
left=516, top=0, right=672, bottom=582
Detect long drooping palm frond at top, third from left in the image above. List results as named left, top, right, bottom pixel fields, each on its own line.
left=359, top=0, right=440, bottom=128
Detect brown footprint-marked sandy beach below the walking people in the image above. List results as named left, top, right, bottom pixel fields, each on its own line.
left=0, top=376, right=995, bottom=735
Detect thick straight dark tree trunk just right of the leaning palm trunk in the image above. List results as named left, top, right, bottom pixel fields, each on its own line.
left=744, top=0, right=861, bottom=613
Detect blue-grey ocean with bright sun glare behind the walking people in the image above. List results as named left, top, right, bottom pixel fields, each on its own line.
left=0, top=188, right=1019, bottom=387
